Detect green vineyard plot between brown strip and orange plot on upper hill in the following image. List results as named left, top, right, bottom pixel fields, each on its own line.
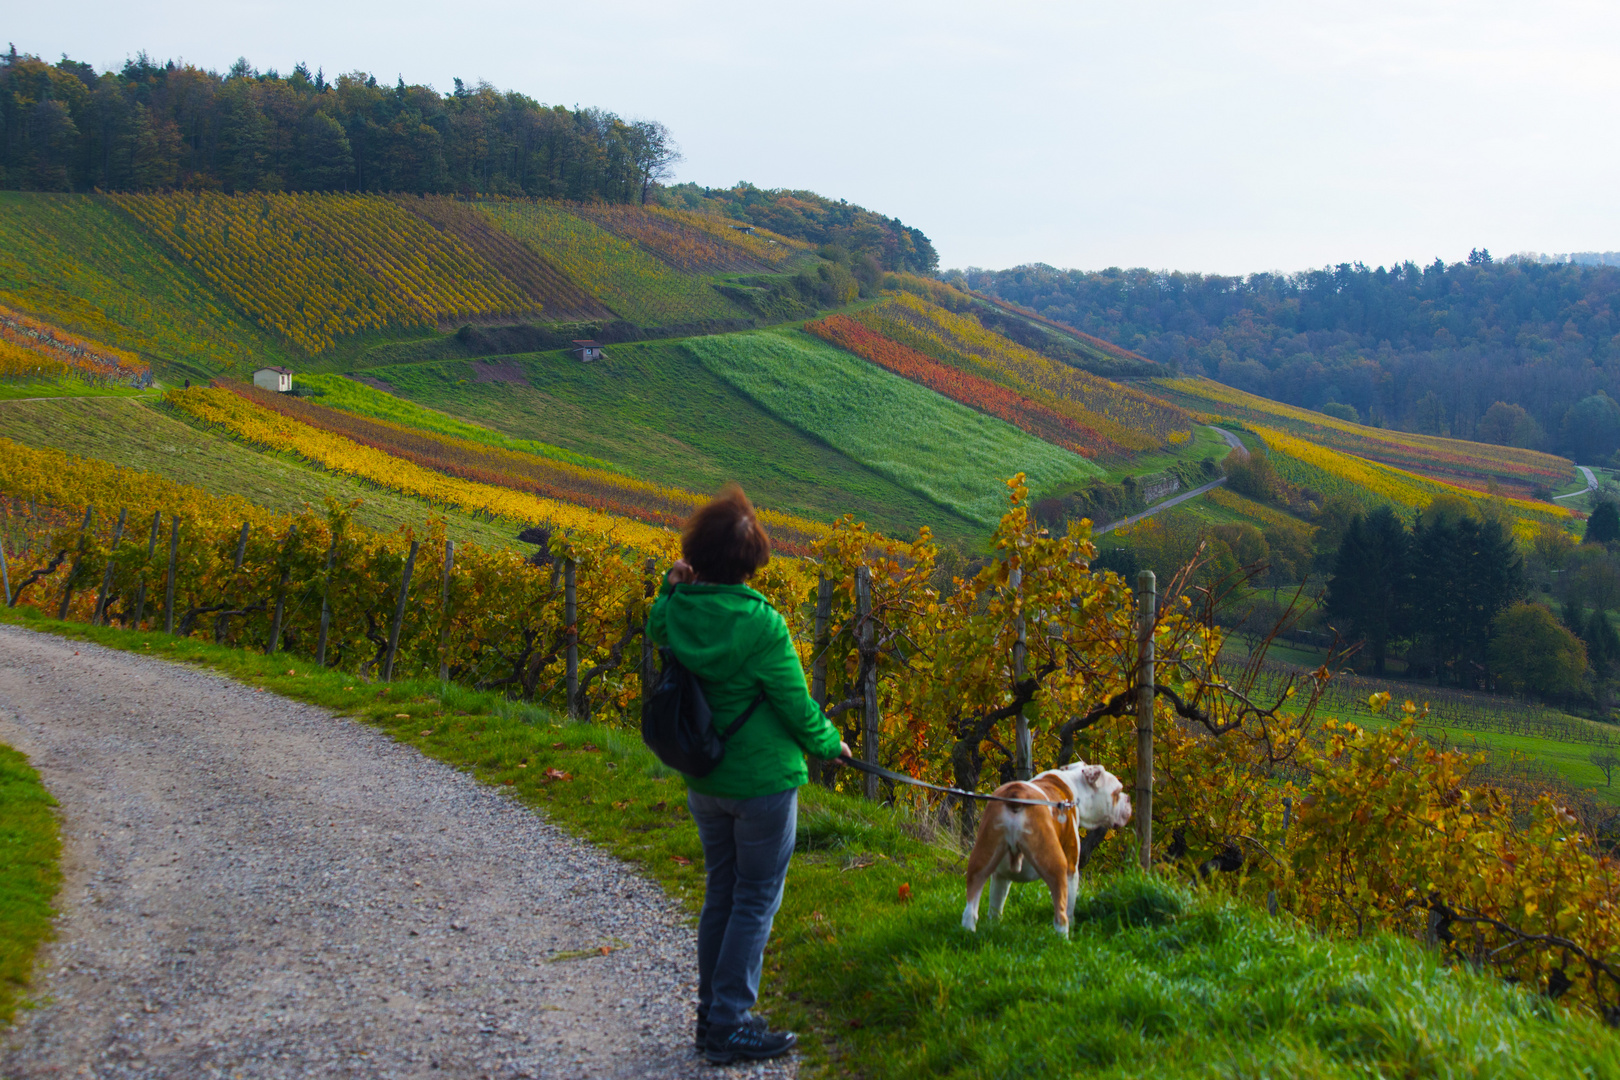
left=475, top=202, right=748, bottom=325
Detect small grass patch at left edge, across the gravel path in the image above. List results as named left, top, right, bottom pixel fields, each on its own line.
left=0, top=745, right=62, bottom=1023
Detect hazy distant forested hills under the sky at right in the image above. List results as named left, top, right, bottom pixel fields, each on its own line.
left=953, top=259, right=1620, bottom=463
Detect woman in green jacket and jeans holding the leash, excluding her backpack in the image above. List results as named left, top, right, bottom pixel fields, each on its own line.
left=646, top=487, right=849, bottom=1064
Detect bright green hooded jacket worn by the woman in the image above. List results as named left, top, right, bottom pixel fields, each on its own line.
left=646, top=580, right=842, bottom=798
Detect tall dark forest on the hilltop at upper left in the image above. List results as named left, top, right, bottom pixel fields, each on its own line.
left=0, top=45, right=679, bottom=202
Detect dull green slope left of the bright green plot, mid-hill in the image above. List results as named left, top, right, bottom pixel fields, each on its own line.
left=345, top=342, right=983, bottom=544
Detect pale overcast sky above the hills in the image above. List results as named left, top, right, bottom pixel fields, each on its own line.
left=6, top=0, right=1620, bottom=274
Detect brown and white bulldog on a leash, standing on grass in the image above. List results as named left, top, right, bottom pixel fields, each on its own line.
left=962, top=761, right=1131, bottom=938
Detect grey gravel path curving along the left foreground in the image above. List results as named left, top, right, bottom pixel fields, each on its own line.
left=0, top=627, right=797, bottom=1080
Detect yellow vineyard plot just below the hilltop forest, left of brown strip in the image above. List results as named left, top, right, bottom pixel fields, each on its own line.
left=109, top=193, right=536, bottom=355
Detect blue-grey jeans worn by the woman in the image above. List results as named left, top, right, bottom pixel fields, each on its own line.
left=687, top=789, right=799, bottom=1028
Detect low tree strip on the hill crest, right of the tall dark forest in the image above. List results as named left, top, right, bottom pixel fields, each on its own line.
left=656, top=183, right=940, bottom=277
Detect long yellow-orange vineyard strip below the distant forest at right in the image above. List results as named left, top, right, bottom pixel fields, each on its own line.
left=1153, top=379, right=1575, bottom=495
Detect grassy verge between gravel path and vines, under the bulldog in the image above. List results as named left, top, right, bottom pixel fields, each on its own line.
left=5, top=610, right=1620, bottom=1078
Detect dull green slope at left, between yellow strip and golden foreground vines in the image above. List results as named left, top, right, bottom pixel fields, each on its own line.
left=0, top=398, right=523, bottom=547
